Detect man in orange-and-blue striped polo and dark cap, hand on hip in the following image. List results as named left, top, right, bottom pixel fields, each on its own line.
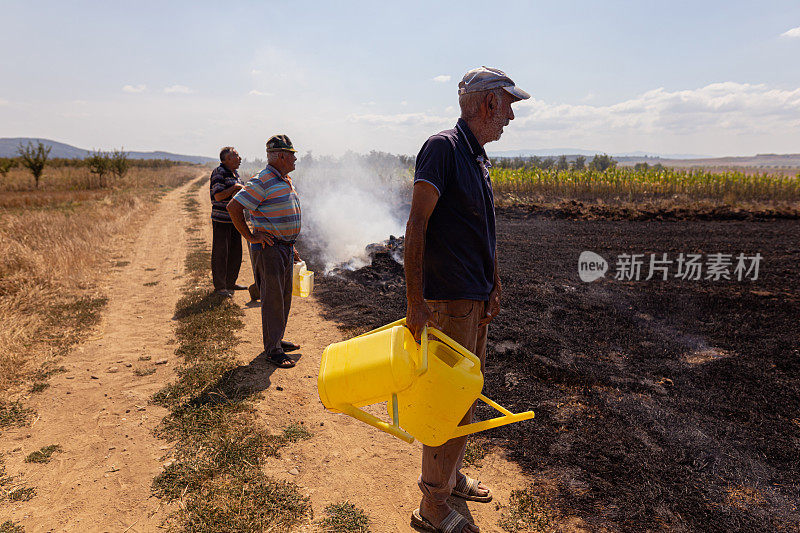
left=228, top=135, right=300, bottom=368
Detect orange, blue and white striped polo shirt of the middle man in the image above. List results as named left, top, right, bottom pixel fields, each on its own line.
left=233, top=165, right=300, bottom=242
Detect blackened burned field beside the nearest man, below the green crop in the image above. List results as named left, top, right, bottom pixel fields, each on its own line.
left=316, top=209, right=800, bottom=532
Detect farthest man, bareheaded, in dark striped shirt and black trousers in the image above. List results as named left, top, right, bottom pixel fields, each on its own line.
left=211, top=146, right=247, bottom=296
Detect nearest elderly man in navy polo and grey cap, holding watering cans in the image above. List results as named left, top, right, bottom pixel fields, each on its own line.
left=405, top=67, right=530, bottom=533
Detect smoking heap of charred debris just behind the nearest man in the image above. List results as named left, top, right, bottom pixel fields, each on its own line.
left=329, top=235, right=405, bottom=295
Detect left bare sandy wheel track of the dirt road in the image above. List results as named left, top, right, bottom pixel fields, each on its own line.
left=0, top=177, right=202, bottom=532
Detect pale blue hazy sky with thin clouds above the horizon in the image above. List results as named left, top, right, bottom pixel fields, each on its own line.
left=0, top=0, right=800, bottom=159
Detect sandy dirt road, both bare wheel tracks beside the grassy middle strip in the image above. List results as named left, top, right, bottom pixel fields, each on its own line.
left=0, top=180, right=544, bottom=532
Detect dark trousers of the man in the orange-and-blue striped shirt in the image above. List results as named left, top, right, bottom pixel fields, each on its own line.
left=250, top=243, right=294, bottom=356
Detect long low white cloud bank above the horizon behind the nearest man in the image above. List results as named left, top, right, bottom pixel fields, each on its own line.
left=347, top=82, right=800, bottom=153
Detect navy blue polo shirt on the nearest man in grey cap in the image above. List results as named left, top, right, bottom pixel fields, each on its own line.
left=414, top=119, right=496, bottom=301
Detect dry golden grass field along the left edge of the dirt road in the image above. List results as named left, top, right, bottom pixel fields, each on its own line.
left=0, top=166, right=198, bottom=408
